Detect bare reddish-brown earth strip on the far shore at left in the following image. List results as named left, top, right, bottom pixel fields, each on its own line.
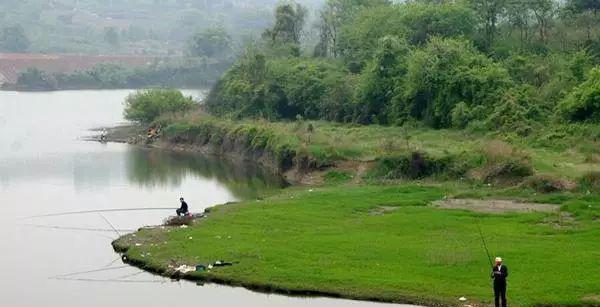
left=0, top=53, right=154, bottom=85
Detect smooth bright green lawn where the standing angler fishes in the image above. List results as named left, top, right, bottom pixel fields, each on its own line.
left=116, top=183, right=600, bottom=306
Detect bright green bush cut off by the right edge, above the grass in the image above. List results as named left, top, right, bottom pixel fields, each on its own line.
left=559, top=67, right=600, bottom=122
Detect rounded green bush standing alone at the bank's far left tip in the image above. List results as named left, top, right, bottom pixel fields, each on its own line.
left=124, top=89, right=195, bottom=123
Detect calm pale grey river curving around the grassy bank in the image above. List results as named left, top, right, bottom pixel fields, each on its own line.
left=0, top=90, right=412, bottom=307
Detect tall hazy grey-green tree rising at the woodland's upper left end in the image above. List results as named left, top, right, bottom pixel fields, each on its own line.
left=262, top=0, right=307, bottom=44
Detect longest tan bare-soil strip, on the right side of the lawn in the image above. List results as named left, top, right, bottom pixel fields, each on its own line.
left=433, top=199, right=560, bottom=213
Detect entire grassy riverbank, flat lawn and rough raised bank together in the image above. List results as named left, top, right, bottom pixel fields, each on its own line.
left=113, top=116, right=600, bottom=306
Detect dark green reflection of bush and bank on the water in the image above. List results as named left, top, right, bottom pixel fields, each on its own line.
left=126, top=147, right=285, bottom=199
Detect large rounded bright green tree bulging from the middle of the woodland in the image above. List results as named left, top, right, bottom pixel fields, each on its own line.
left=395, top=38, right=512, bottom=128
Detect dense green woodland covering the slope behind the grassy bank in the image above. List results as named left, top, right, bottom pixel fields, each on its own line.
left=207, top=0, right=600, bottom=135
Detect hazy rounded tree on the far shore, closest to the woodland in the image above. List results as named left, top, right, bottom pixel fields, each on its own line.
left=189, top=27, right=232, bottom=58
